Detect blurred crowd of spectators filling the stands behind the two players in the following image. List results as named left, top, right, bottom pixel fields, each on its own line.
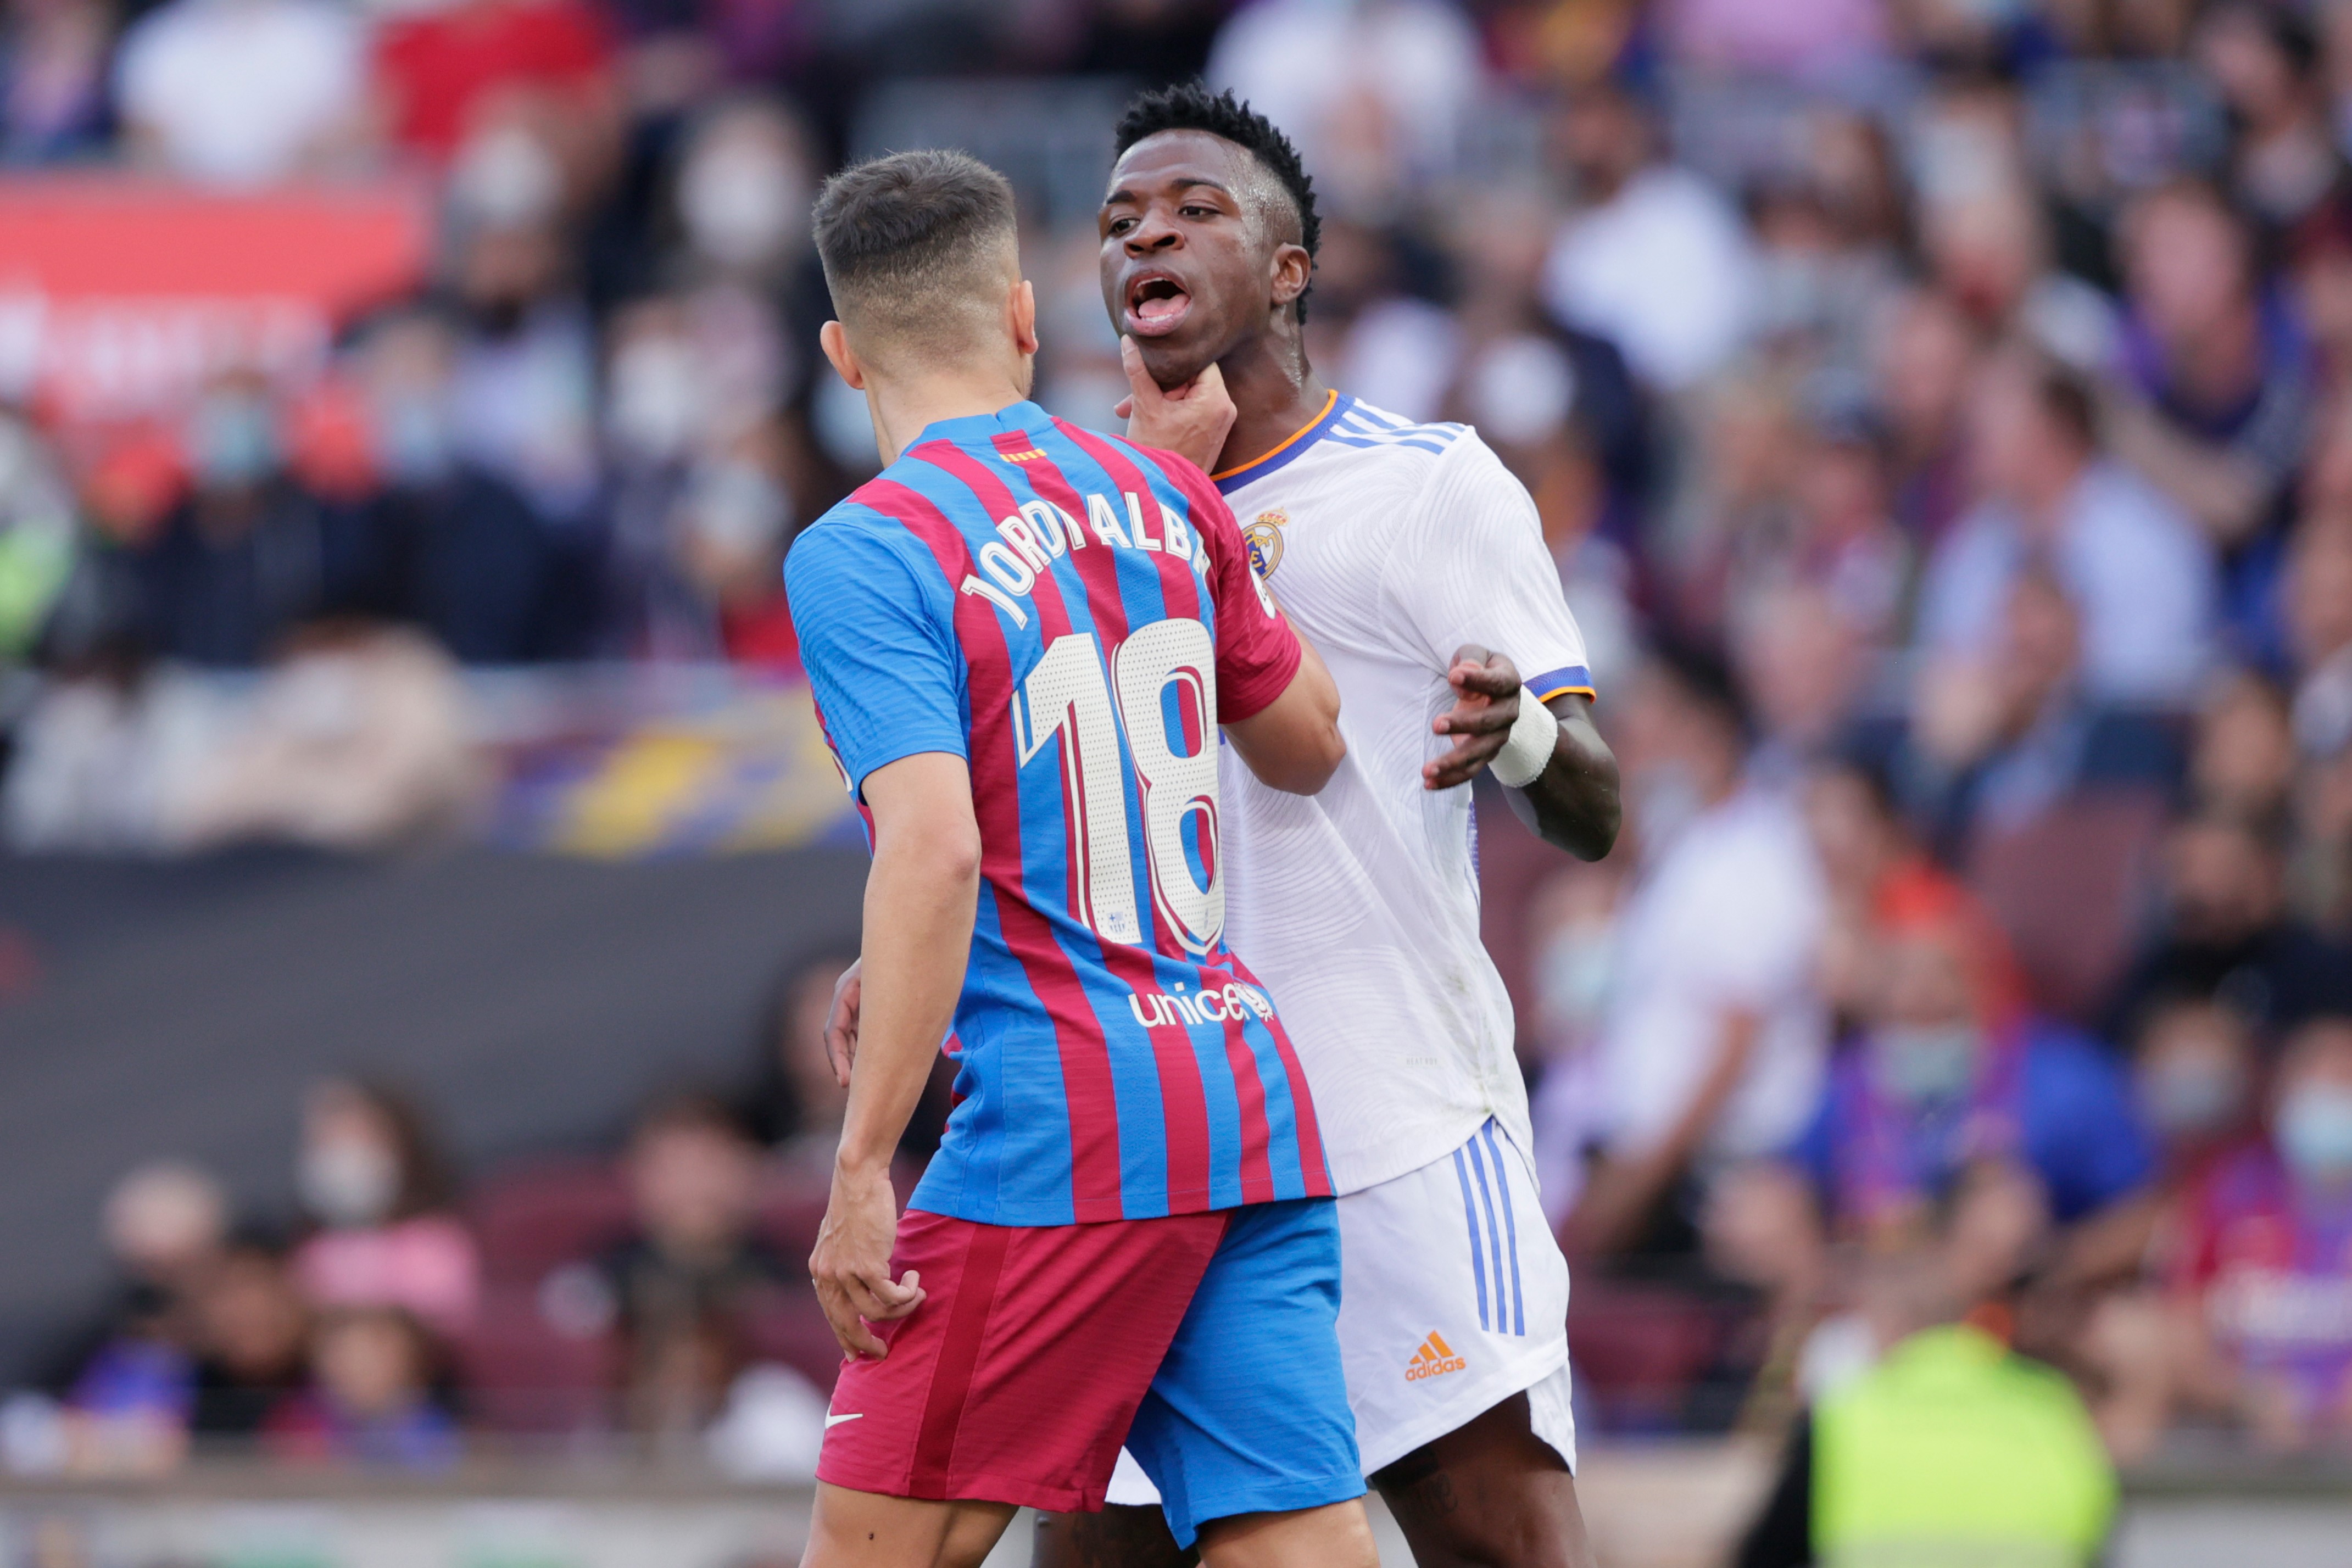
left=0, top=0, right=2352, bottom=1462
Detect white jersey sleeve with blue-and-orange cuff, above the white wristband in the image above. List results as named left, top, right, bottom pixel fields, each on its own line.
left=1383, top=433, right=1592, bottom=703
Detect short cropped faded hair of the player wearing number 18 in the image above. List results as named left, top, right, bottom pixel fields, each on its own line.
left=814, top=148, right=1018, bottom=348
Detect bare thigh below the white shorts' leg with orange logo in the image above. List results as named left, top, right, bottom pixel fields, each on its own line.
left=1371, top=1394, right=1592, bottom=1568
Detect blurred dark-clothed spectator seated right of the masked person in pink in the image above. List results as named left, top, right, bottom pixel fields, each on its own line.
left=600, top=1100, right=799, bottom=1446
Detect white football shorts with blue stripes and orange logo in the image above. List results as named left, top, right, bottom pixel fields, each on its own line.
left=1108, top=1119, right=1576, bottom=1504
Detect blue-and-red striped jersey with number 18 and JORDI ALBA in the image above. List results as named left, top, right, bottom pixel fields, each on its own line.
left=785, top=402, right=1331, bottom=1225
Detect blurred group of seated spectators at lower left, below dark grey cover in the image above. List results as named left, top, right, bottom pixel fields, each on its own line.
left=0, top=952, right=917, bottom=1481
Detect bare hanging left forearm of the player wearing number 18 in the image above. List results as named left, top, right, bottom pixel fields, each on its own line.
left=840, top=830, right=978, bottom=1168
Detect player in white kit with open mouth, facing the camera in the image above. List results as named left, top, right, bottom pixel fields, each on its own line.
left=1040, top=87, right=1618, bottom=1568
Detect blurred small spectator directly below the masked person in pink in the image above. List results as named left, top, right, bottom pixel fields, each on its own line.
left=261, top=1305, right=459, bottom=1469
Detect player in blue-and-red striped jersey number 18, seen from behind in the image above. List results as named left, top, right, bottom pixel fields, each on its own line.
left=785, top=153, right=1376, bottom=1568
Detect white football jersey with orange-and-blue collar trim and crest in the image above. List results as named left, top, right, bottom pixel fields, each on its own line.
left=1218, top=395, right=1592, bottom=1192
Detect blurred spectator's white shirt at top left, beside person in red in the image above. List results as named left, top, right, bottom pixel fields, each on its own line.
left=115, top=0, right=367, bottom=186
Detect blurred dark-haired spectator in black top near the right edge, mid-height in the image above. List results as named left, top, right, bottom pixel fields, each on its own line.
left=2108, top=811, right=2352, bottom=1039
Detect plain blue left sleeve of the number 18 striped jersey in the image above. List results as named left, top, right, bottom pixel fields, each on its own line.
left=783, top=517, right=969, bottom=799
